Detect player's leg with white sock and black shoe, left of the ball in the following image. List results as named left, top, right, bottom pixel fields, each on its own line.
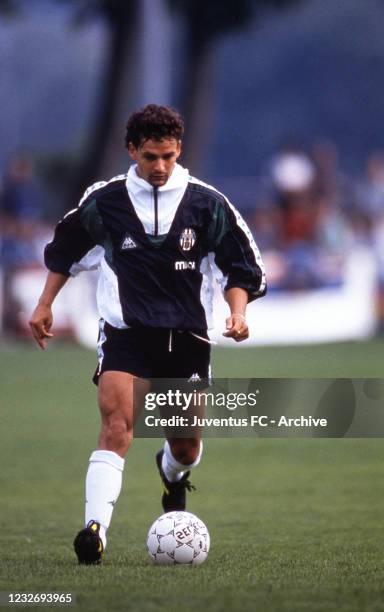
left=75, top=371, right=149, bottom=563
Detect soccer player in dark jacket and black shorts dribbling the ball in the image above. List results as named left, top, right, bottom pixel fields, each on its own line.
left=30, top=104, right=266, bottom=564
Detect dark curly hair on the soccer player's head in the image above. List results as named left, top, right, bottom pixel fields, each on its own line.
left=125, top=104, right=184, bottom=149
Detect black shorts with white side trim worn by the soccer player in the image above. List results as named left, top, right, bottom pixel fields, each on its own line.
left=93, top=319, right=211, bottom=389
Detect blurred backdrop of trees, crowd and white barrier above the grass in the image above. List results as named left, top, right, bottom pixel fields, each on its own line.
left=0, top=0, right=384, bottom=347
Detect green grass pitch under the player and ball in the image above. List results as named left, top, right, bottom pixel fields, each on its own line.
left=0, top=340, right=384, bottom=612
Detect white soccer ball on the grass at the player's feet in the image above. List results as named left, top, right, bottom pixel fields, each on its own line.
left=147, top=512, right=210, bottom=565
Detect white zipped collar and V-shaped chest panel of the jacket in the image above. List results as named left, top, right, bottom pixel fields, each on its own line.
left=126, top=164, right=189, bottom=235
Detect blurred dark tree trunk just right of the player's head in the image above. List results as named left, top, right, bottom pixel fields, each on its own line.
left=168, top=0, right=301, bottom=175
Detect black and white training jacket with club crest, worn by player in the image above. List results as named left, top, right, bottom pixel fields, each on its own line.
left=45, top=164, right=266, bottom=330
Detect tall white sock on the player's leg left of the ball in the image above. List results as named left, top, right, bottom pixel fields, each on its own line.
left=85, top=450, right=124, bottom=548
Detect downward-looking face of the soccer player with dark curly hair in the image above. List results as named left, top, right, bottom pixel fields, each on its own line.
left=128, top=138, right=181, bottom=187
